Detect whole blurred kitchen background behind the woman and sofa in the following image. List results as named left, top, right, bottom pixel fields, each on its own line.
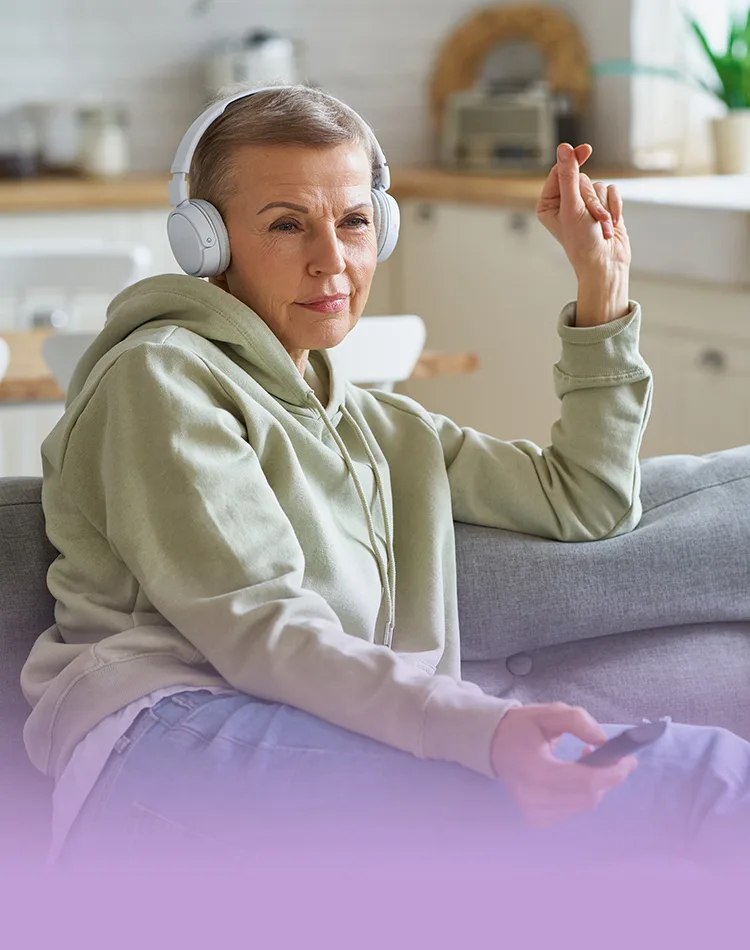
left=0, top=0, right=750, bottom=474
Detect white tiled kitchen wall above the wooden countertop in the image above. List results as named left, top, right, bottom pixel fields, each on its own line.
left=0, top=0, right=633, bottom=169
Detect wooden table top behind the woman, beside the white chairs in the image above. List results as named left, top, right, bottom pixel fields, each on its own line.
left=0, top=330, right=479, bottom=403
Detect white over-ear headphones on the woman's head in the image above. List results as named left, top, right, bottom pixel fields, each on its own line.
left=167, top=86, right=400, bottom=277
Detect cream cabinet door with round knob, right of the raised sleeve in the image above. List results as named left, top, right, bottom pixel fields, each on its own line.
left=641, top=324, right=750, bottom=458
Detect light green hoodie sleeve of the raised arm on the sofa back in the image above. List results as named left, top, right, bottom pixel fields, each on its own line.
left=433, top=303, right=652, bottom=541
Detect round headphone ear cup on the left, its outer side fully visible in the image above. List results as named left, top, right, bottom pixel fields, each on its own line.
left=167, top=198, right=231, bottom=277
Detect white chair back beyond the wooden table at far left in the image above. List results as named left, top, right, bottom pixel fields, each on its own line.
left=0, top=240, right=152, bottom=330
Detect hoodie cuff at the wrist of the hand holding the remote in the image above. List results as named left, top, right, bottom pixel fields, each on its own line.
left=422, top=682, right=521, bottom=778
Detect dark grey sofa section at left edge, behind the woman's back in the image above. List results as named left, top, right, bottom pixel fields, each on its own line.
left=0, top=478, right=56, bottom=860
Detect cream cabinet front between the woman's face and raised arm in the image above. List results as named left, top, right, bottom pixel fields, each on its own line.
left=396, top=201, right=575, bottom=444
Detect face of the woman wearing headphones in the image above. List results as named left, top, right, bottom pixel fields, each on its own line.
left=213, top=144, right=377, bottom=371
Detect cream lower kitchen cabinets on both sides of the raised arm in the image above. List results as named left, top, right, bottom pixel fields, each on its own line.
left=391, top=201, right=750, bottom=457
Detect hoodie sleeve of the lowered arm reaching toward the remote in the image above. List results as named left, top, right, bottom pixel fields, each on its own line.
left=62, top=344, right=517, bottom=776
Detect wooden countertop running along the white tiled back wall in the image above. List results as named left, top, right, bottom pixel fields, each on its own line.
left=0, top=166, right=668, bottom=214
